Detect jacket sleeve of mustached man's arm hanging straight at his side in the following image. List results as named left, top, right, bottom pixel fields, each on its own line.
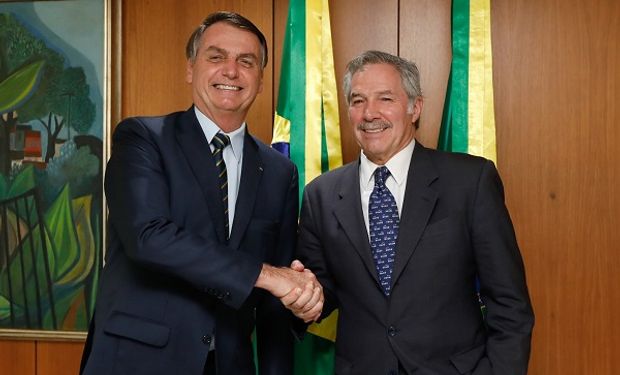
left=471, top=161, right=534, bottom=375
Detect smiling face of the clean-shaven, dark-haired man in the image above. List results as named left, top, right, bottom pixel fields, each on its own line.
left=186, top=22, right=263, bottom=132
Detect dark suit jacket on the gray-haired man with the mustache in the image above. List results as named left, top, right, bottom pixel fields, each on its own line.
left=298, top=143, right=534, bottom=375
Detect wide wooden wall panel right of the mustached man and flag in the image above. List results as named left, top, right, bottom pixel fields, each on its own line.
left=492, top=0, right=620, bottom=375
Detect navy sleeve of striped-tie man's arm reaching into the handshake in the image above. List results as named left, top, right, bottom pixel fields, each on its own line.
left=105, top=118, right=261, bottom=308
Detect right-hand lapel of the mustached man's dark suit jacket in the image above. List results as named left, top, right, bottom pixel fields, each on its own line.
left=392, top=143, right=438, bottom=285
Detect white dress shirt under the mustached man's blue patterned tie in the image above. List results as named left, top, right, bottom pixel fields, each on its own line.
left=360, top=139, right=415, bottom=238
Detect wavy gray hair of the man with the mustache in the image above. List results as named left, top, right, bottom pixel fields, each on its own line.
left=343, top=51, right=422, bottom=107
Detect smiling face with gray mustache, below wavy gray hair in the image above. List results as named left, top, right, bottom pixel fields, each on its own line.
left=349, top=63, right=422, bottom=165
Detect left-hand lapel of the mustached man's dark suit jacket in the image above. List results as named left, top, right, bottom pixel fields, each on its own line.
left=334, top=162, right=379, bottom=285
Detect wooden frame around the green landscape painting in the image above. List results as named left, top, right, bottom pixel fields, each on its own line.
left=0, top=0, right=122, bottom=341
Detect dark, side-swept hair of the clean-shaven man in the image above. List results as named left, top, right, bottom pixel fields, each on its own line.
left=185, top=12, right=267, bottom=69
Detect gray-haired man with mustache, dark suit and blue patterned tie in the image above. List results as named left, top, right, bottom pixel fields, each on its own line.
left=294, top=51, right=534, bottom=375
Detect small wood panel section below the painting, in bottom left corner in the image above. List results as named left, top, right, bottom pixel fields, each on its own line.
left=0, top=340, right=36, bottom=375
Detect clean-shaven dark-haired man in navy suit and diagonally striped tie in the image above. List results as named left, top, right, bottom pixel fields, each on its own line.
left=83, top=12, right=320, bottom=375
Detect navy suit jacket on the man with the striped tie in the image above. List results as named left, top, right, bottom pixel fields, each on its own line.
left=84, top=108, right=298, bottom=375
